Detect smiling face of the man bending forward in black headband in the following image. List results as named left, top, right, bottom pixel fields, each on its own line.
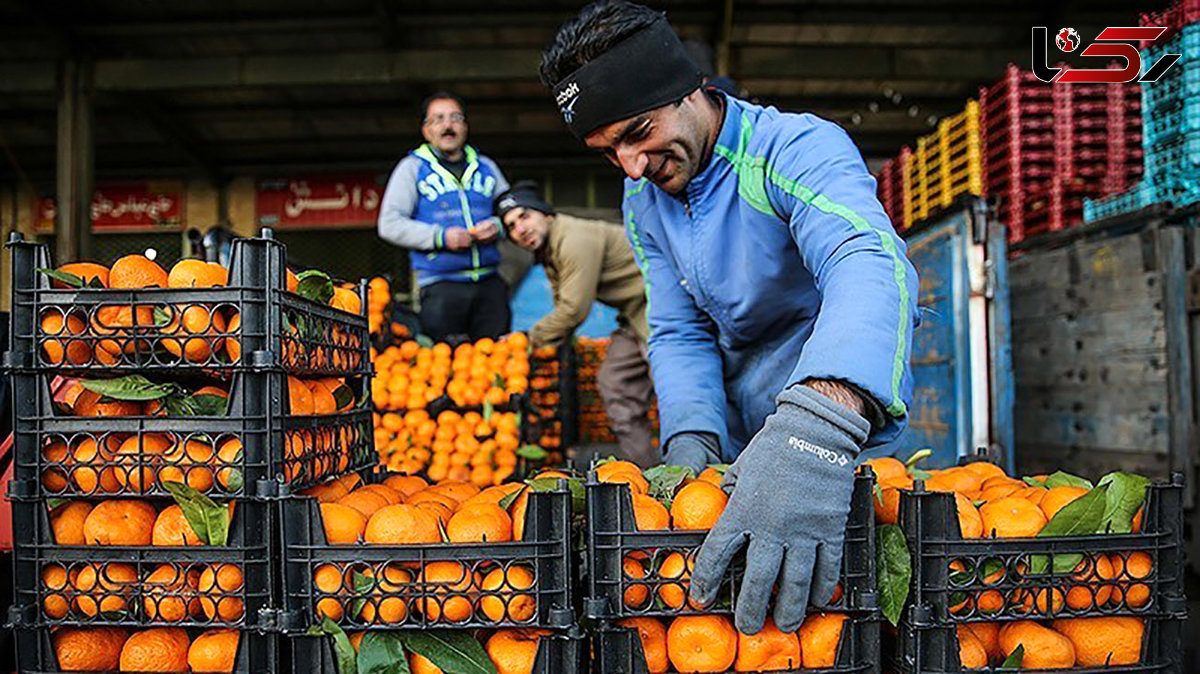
left=584, top=89, right=708, bottom=194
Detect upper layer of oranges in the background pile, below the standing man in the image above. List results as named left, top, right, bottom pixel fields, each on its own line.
left=371, top=332, right=529, bottom=411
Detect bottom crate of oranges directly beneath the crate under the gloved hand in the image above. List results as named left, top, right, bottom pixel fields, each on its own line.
left=593, top=612, right=880, bottom=674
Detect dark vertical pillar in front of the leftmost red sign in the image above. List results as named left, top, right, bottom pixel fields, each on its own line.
left=54, top=59, right=95, bottom=264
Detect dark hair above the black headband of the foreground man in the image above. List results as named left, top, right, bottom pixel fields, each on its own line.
left=540, top=0, right=662, bottom=86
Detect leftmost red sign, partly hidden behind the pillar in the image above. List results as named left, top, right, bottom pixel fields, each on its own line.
left=34, top=182, right=184, bottom=233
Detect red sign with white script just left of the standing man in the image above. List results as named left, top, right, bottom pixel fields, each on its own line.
left=254, top=175, right=384, bottom=229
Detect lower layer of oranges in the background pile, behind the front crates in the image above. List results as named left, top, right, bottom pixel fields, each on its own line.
left=374, top=409, right=520, bottom=488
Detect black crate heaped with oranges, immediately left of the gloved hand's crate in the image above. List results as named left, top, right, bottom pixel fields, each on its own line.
left=281, top=473, right=575, bottom=631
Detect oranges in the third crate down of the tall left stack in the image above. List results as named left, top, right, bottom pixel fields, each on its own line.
left=41, top=499, right=245, bottom=624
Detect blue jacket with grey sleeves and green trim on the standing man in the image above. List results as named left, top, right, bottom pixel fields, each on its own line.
left=378, top=143, right=509, bottom=287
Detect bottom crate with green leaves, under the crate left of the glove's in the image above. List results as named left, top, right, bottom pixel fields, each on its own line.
left=288, top=627, right=589, bottom=674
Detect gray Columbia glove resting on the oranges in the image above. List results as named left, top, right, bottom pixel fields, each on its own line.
left=691, top=386, right=870, bottom=634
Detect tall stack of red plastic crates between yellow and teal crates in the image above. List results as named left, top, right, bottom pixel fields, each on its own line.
left=979, top=65, right=1142, bottom=242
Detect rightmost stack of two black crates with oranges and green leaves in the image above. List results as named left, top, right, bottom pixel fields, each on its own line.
left=871, top=450, right=1186, bottom=672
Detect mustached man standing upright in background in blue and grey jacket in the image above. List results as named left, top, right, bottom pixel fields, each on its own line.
left=379, top=91, right=512, bottom=339
